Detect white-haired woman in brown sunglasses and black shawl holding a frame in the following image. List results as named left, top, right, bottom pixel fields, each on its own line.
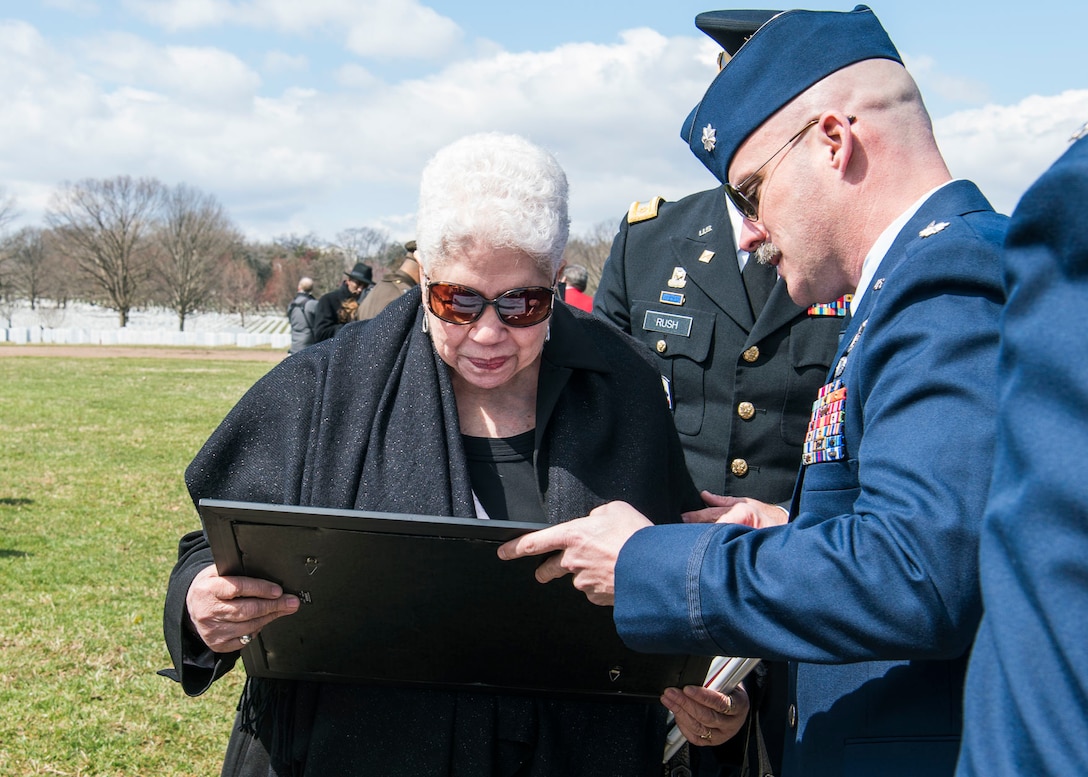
left=164, top=134, right=701, bottom=777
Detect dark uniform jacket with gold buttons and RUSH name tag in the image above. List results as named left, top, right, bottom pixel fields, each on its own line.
left=593, top=187, right=842, bottom=503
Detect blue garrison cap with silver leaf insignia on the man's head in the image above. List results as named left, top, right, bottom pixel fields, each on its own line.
left=680, top=5, right=903, bottom=183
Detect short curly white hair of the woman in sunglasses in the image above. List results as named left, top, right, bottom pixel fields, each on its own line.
left=416, top=133, right=570, bottom=275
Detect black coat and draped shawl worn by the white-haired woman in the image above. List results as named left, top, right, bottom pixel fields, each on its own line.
left=164, top=289, right=697, bottom=777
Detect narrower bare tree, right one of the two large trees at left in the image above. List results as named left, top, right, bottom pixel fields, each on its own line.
left=154, top=184, right=242, bottom=332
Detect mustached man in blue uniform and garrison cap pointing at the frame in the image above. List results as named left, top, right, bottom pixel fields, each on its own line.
left=499, top=7, right=1007, bottom=777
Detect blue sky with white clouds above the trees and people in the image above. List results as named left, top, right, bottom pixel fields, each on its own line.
left=6, top=0, right=1088, bottom=239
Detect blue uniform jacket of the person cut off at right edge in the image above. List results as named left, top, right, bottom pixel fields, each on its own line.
left=956, top=138, right=1088, bottom=777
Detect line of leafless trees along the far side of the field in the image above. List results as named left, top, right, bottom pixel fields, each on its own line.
left=0, top=175, right=615, bottom=331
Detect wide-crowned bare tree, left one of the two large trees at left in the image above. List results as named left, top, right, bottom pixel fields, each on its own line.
left=46, top=175, right=162, bottom=326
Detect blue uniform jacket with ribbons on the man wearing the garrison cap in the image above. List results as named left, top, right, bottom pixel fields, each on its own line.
left=615, top=181, right=1006, bottom=777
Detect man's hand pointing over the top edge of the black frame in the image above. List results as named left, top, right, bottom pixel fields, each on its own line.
left=498, top=502, right=652, bottom=605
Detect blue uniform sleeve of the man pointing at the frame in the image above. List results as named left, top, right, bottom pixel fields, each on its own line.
left=615, top=223, right=1003, bottom=663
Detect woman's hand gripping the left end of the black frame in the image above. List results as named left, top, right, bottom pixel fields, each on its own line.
left=185, top=565, right=299, bottom=653
